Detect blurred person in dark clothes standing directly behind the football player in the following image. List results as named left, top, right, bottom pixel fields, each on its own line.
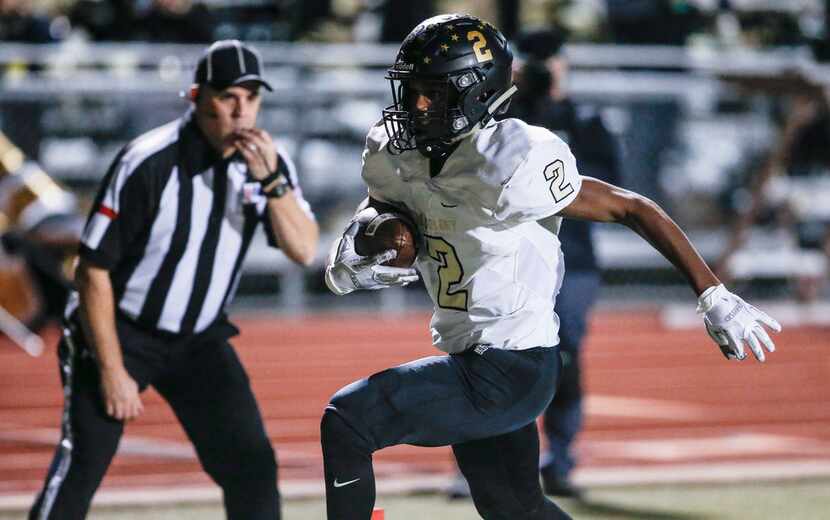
left=508, top=26, right=620, bottom=496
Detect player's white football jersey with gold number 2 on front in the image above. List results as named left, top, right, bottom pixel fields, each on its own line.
left=363, top=119, right=582, bottom=353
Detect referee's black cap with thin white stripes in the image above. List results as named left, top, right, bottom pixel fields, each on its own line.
left=194, top=40, right=274, bottom=91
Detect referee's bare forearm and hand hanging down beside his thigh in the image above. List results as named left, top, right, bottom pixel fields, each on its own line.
left=75, top=259, right=144, bottom=421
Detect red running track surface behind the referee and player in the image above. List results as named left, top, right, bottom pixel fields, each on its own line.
left=0, top=311, right=830, bottom=495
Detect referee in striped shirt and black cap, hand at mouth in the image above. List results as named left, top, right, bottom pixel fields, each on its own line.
left=30, top=40, right=318, bottom=520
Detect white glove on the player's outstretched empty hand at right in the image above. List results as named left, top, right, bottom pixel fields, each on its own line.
left=697, top=284, right=781, bottom=362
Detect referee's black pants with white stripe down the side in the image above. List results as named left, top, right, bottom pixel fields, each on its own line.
left=29, top=319, right=280, bottom=520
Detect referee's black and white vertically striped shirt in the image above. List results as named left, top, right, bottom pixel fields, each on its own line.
left=68, top=112, right=311, bottom=334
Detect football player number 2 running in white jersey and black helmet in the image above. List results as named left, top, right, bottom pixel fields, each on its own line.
left=321, top=14, right=780, bottom=520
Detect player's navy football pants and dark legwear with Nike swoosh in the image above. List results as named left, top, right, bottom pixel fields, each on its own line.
left=321, top=347, right=569, bottom=520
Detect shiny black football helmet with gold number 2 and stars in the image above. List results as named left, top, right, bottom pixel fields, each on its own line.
left=383, top=14, right=516, bottom=157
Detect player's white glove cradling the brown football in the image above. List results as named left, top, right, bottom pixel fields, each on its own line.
left=326, top=222, right=418, bottom=296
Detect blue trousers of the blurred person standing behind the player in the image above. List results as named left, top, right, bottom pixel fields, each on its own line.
left=542, top=271, right=600, bottom=479
